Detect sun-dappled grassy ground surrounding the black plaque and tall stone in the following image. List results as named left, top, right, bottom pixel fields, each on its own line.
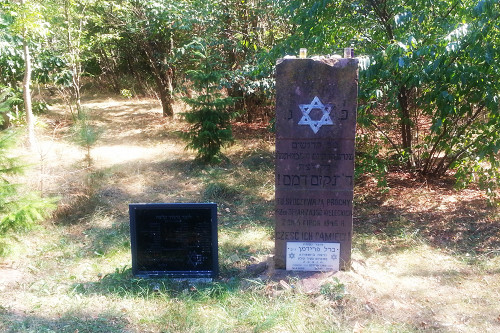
left=0, top=94, right=500, bottom=333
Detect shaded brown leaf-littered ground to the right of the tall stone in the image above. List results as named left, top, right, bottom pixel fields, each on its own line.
left=354, top=173, right=500, bottom=257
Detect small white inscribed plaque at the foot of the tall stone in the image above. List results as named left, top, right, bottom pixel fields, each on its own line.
left=286, top=242, right=340, bottom=272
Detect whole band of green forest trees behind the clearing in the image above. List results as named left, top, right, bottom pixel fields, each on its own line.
left=0, top=0, right=500, bottom=189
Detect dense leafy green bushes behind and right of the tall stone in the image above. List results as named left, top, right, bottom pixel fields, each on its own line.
left=283, top=0, right=500, bottom=198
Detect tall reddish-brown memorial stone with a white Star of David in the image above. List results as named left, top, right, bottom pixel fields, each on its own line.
left=275, top=58, right=358, bottom=270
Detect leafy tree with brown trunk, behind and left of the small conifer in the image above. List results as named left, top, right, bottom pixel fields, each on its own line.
left=88, top=1, right=202, bottom=117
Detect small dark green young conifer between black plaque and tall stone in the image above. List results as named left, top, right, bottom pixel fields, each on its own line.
left=184, top=42, right=235, bottom=163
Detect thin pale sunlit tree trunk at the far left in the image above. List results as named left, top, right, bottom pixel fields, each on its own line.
left=21, top=0, right=36, bottom=149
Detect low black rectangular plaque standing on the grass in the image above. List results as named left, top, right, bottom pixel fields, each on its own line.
left=129, top=203, right=219, bottom=279
